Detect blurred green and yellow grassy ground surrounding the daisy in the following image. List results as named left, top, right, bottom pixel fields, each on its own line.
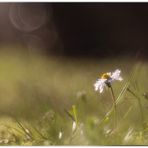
left=0, top=49, right=148, bottom=145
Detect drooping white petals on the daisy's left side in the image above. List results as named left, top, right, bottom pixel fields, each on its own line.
left=94, top=79, right=106, bottom=93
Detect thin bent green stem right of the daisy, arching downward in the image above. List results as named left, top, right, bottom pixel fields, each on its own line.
left=127, top=88, right=144, bottom=128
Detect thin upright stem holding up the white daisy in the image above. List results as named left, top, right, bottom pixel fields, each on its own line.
left=110, top=85, right=117, bottom=128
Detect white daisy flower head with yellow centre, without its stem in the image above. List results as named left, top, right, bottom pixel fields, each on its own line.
left=94, top=69, right=123, bottom=93
